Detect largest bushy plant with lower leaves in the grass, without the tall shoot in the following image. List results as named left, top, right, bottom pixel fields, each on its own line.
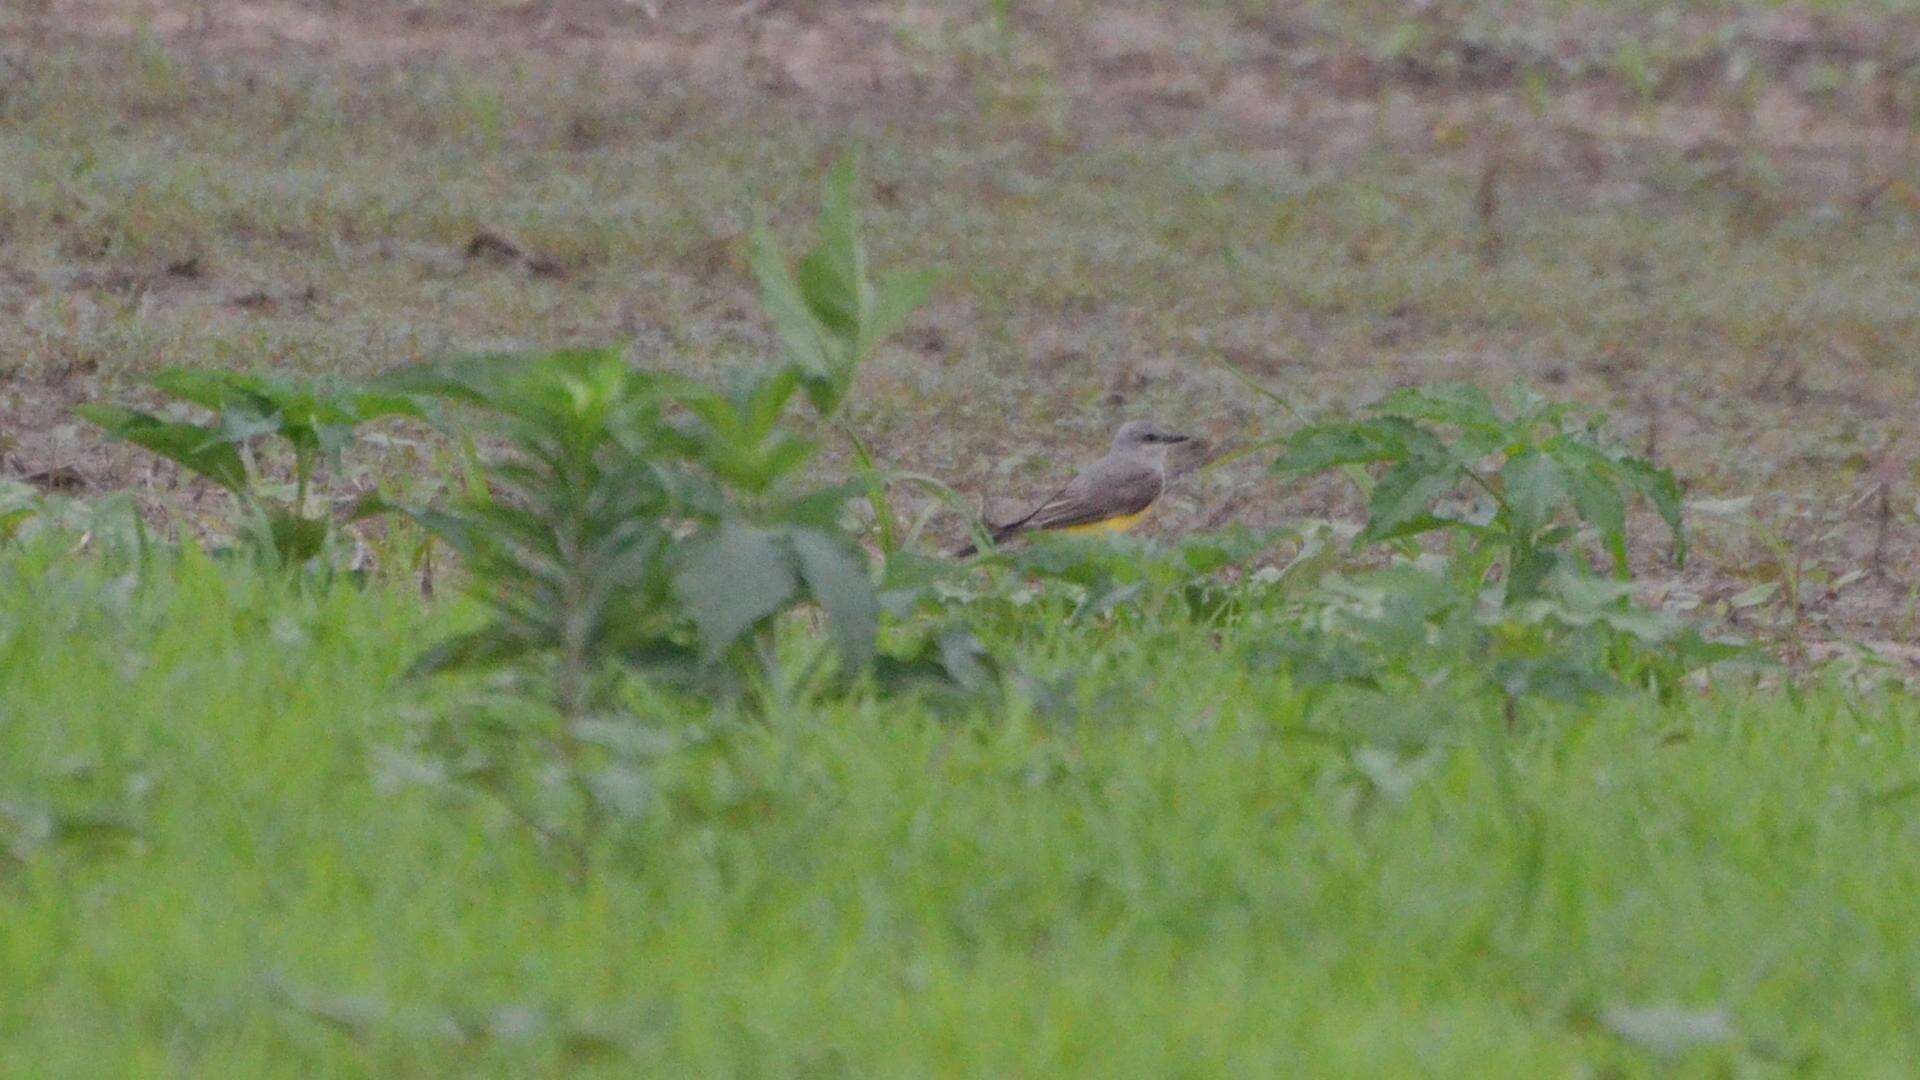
left=363, top=350, right=877, bottom=872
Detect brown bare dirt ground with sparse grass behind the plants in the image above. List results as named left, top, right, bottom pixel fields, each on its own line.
left=0, top=0, right=1920, bottom=642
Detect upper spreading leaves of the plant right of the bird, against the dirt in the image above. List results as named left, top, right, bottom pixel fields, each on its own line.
left=1273, top=386, right=1686, bottom=605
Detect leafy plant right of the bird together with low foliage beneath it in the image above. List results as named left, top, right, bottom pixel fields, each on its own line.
left=1256, top=384, right=1745, bottom=717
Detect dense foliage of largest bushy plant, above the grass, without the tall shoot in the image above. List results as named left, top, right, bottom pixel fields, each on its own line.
left=369, top=350, right=877, bottom=700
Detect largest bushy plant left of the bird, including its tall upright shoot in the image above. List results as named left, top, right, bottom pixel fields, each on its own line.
left=365, top=158, right=958, bottom=865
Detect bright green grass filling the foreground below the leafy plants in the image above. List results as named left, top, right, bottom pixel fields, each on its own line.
left=0, top=542, right=1920, bottom=1076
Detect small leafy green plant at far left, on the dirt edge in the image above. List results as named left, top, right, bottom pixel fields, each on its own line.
left=75, top=367, right=420, bottom=567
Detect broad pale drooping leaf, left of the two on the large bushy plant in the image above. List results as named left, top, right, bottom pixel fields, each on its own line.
left=674, top=521, right=799, bottom=661
